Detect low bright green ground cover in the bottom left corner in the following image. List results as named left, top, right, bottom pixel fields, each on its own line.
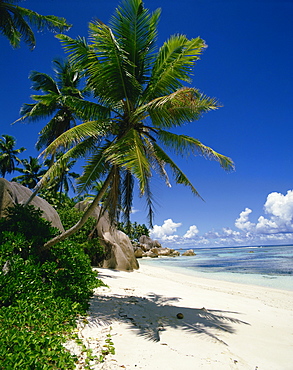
left=0, top=296, right=77, bottom=370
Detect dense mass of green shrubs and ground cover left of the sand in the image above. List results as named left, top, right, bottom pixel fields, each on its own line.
left=0, top=206, right=102, bottom=370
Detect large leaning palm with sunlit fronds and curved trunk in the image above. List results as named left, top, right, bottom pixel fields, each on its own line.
left=37, top=0, right=233, bottom=248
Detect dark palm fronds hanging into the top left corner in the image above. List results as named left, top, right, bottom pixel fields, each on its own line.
left=0, top=0, right=71, bottom=49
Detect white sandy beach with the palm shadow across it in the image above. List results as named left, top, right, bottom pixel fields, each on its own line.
left=71, top=265, right=293, bottom=370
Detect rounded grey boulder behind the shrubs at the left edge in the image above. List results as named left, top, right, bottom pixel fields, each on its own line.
left=0, top=178, right=64, bottom=232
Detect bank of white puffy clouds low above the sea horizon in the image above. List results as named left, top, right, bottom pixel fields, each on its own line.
left=150, top=190, right=293, bottom=248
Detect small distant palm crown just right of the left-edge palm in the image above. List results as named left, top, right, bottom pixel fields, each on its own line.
left=11, top=156, right=46, bottom=189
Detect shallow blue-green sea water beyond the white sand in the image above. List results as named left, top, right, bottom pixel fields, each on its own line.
left=139, top=245, right=293, bottom=290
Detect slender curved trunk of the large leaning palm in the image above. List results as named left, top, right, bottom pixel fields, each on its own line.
left=41, top=170, right=113, bottom=250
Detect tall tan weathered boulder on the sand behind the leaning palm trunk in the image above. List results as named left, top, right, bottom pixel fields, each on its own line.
left=76, top=202, right=139, bottom=271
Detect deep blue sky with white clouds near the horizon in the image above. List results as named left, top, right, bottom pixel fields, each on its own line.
left=0, top=0, right=293, bottom=247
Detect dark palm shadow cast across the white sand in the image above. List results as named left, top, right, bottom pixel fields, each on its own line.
left=88, top=289, right=249, bottom=344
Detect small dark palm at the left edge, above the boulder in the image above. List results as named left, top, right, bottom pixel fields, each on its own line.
left=0, top=135, right=26, bottom=177
